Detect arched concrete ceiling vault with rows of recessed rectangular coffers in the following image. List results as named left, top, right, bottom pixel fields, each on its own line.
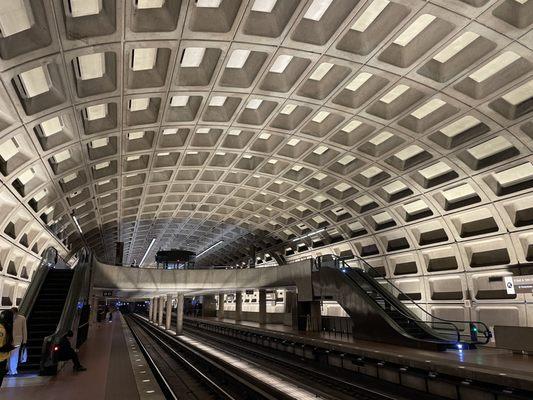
left=0, top=0, right=533, bottom=263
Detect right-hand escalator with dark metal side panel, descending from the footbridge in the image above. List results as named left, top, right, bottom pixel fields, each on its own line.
left=317, top=256, right=492, bottom=350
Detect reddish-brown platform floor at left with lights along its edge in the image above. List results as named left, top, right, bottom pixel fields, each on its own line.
left=0, top=312, right=164, bottom=400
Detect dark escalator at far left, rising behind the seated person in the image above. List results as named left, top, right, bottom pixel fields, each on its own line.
left=18, top=248, right=90, bottom=375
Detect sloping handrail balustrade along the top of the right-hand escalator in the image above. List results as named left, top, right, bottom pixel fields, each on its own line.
left=316, top=254, right=492, bottom=344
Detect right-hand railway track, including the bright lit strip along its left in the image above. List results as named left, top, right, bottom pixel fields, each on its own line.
left=130, top=316, right=444, bottom=400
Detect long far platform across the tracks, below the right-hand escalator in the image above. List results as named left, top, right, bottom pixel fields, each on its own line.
left=186, top=317, right=533, bottom=391
